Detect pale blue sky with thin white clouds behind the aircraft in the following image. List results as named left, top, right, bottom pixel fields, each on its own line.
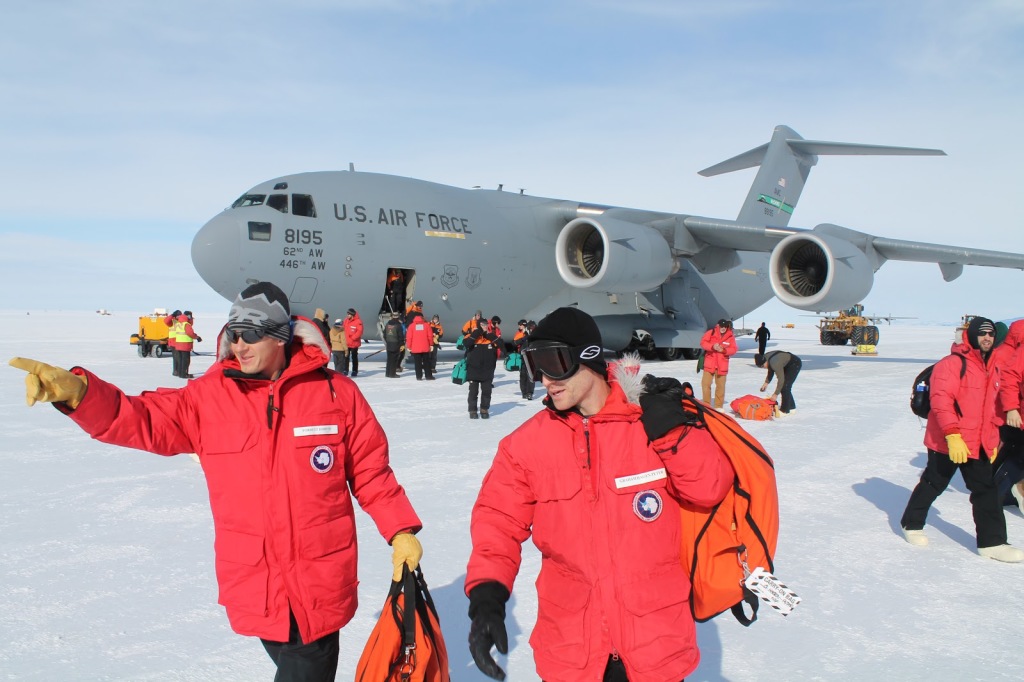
left=0, top=0, right=1024, bottom=323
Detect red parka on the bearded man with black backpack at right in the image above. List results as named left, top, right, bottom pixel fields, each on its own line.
left=925, top=330, right=999, bottom=460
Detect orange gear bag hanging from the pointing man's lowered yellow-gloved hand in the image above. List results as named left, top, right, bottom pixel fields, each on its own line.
left=355, top=566, right=452, bottom=682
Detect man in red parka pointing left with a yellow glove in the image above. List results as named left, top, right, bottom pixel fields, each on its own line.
left=10, top=282, right=422, bottom=680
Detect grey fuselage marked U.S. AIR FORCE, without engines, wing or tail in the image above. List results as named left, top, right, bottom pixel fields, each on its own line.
left=191, top=171, right=772, bottom=348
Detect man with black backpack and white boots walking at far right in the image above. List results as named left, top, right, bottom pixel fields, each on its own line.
left=900, top=316, right=1024, bottom=563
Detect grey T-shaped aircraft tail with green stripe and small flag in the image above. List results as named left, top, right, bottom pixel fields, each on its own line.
left=700, top=126, right=945, bottom=227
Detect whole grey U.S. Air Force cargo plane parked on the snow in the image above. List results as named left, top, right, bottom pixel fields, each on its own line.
left=191, top=126, right=1024, bottom=359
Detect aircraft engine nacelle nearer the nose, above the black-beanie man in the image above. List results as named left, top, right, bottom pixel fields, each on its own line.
left=555, top=217, right=679, bottom=294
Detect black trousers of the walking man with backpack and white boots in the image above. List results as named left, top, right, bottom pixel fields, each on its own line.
left=900, top=450, right=1007, bottom=548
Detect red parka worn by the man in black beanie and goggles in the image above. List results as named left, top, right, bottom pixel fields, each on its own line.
left=466, top=372, right=733, bottom=682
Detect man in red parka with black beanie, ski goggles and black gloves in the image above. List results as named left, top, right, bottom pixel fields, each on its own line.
left=465, top=308, right=734, bottom=682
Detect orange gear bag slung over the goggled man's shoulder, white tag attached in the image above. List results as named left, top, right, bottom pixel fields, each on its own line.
left=680, top=383, right=778, bottom=626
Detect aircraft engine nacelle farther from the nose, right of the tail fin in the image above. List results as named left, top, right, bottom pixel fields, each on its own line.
left=768, top=232, right=874, bottom=311
